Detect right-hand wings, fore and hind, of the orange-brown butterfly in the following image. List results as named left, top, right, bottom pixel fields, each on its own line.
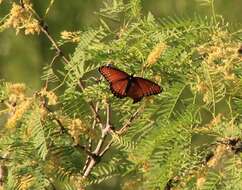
left=127, top=77, right=162, bottom=103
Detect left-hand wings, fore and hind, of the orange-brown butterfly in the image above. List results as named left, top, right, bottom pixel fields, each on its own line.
left=99, top=66, right=129, bottom=98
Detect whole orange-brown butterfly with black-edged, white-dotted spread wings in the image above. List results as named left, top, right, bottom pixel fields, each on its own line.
left=98, top=66, right=162, bottom=103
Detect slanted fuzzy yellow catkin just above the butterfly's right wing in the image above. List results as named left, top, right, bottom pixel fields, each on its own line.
left=147, top=42, right=167, bottom=66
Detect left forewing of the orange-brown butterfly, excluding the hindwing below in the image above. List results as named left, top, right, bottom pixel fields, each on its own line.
left=99, top=66, right=129, bottom=84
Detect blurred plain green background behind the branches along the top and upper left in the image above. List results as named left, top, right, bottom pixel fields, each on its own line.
left=0, top=0, right=242, bottom=89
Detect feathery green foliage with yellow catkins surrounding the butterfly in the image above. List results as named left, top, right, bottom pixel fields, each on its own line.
left=0, top=0, right=242, bottom=190
